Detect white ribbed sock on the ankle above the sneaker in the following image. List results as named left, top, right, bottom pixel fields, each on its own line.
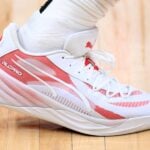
left=18, top=0, right=117, bottom=53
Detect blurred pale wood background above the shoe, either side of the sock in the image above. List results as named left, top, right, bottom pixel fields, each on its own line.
left=0, top=0, right=150, bottom=91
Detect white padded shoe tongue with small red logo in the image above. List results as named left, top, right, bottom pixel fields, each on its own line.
left=64, top=28, right=98, bottom=56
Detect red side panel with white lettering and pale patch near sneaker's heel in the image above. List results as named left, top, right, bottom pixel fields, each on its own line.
left=0, top=50, right=79, bottom=101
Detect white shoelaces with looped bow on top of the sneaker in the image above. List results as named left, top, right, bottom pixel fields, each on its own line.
left=63, top=50, right=132, bottom=98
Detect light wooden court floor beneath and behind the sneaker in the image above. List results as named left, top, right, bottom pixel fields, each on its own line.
left=0, top=0, right=150, bottom=150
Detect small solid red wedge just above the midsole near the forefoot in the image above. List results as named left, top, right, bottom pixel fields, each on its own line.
left=95, top=106, right=125, bottom=120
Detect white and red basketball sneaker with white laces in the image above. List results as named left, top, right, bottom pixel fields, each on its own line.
left=0, top=24, right=150, bottom=136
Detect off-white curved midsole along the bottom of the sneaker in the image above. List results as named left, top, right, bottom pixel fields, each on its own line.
left=0, top=105, right=150, bottom=136
